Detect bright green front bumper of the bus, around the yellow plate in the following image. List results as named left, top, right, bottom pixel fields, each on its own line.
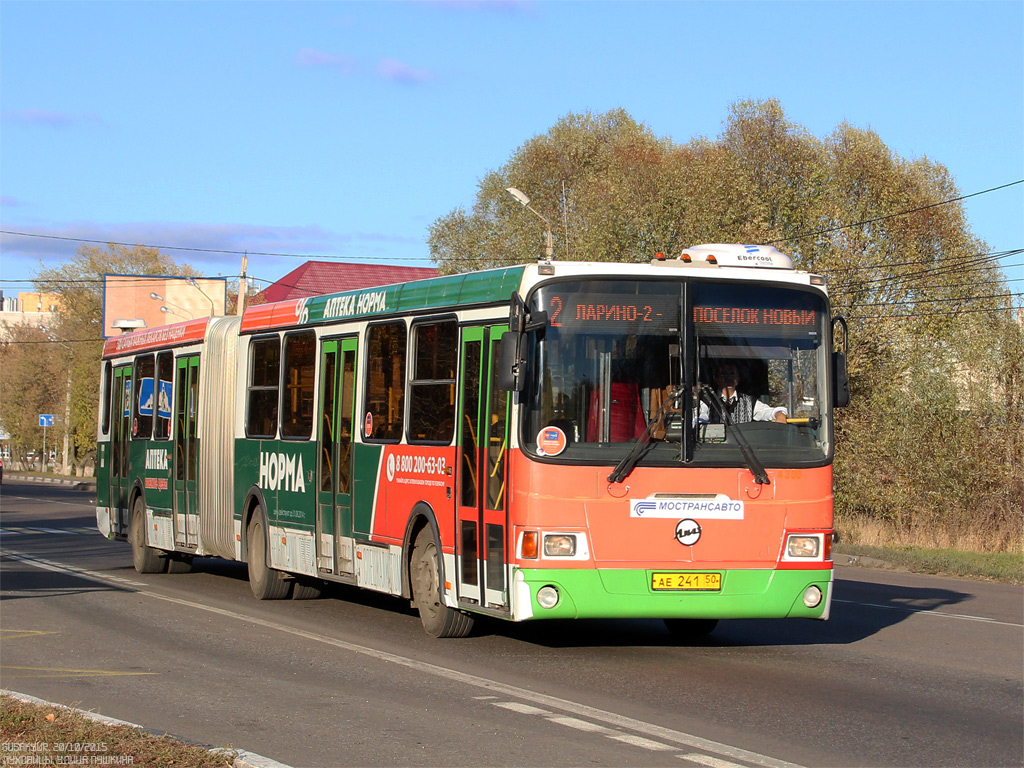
left=515, top=568, right=833, bottom=620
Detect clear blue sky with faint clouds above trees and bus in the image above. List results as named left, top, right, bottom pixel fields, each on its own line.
left=0, top=0, right=1024, bottom=295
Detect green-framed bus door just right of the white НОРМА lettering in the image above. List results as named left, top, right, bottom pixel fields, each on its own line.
left=316, top=336, right=356, bottom=574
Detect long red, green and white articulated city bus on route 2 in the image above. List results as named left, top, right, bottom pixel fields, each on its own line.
left=96, top=245, right=848, bottom=637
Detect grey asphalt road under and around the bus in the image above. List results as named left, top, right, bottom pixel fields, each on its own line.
left=0, top=478, right=1024, bottom=768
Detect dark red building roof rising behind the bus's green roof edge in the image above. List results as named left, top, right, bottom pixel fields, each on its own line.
left=258, top=261, right=437, bottom=304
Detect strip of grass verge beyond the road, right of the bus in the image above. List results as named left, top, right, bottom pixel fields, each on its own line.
left=836, top=544, right=1024, bottom=585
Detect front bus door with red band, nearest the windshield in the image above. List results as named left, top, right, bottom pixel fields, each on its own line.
left=456, top=327, right=509, bottom=611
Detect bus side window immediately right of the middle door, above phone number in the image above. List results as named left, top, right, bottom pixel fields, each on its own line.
left=362, top=321, right=407, bottom=442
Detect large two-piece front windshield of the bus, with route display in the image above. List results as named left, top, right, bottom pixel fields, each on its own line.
left=521, top=280, right=831, bottom=467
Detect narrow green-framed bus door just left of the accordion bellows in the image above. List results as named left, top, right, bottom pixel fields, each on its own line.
left=172, top=354, right=199, bottom=547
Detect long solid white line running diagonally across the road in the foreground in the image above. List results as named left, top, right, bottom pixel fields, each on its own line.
left=0, top=550, right=801, bottom=768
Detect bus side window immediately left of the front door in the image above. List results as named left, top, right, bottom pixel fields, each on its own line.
left=409, top=319, right=459, bottom=443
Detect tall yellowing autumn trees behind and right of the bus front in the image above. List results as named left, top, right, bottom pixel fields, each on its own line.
left=428, top=100, right=1024, bottom=548
